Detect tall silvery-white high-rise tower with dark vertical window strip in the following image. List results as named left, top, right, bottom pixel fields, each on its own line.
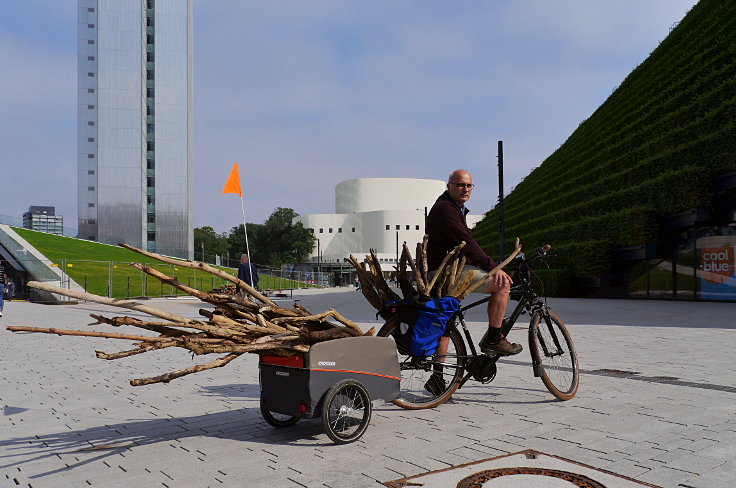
left=77, top=0, right=194, bottom=257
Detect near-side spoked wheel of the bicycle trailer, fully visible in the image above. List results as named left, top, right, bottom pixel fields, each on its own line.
left=322, top=380, right=371, bottom=444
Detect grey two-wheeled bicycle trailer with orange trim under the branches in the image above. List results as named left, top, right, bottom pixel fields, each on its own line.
left=259, top=337, right=401, bottom=444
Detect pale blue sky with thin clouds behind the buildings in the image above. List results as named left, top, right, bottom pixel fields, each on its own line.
left=0, top=0, right=697, bottom=232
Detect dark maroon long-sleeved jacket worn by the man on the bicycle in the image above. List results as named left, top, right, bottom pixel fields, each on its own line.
left=425, top=191, right=496, bottom=271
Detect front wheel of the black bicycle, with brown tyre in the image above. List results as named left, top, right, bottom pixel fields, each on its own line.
left=529, top=310, right=580, bottom=400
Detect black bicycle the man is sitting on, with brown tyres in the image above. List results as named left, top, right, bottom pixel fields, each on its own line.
left=378, top=246, right=580, bottom=410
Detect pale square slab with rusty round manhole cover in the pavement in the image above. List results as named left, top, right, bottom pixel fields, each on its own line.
left=384, top=449, right=660, bottom=488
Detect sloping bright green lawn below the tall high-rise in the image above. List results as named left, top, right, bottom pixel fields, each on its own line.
left=13, top=227, right=308, bottom=298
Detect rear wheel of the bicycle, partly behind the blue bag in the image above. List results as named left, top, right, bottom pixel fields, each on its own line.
left=378, top=321, right=466, bottom=410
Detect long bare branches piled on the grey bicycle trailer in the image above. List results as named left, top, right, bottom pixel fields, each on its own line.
left=7, top=244, right=374, bottom=386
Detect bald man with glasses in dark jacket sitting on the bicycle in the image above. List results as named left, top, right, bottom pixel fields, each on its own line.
left=426, top=169, right=522, bottom=356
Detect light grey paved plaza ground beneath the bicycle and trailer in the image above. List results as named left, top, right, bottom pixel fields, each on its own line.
left=0, top=288, right=736, bottom=488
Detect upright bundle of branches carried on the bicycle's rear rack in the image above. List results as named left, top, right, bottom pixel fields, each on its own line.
left=345, top=235, right=521, bottom=318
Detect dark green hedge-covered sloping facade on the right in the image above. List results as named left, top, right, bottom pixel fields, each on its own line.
left=474, top=0, right=736, bottom=294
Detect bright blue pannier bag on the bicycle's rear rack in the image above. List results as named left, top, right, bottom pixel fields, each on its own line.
left=386, top=297, right=460, bottom=356
